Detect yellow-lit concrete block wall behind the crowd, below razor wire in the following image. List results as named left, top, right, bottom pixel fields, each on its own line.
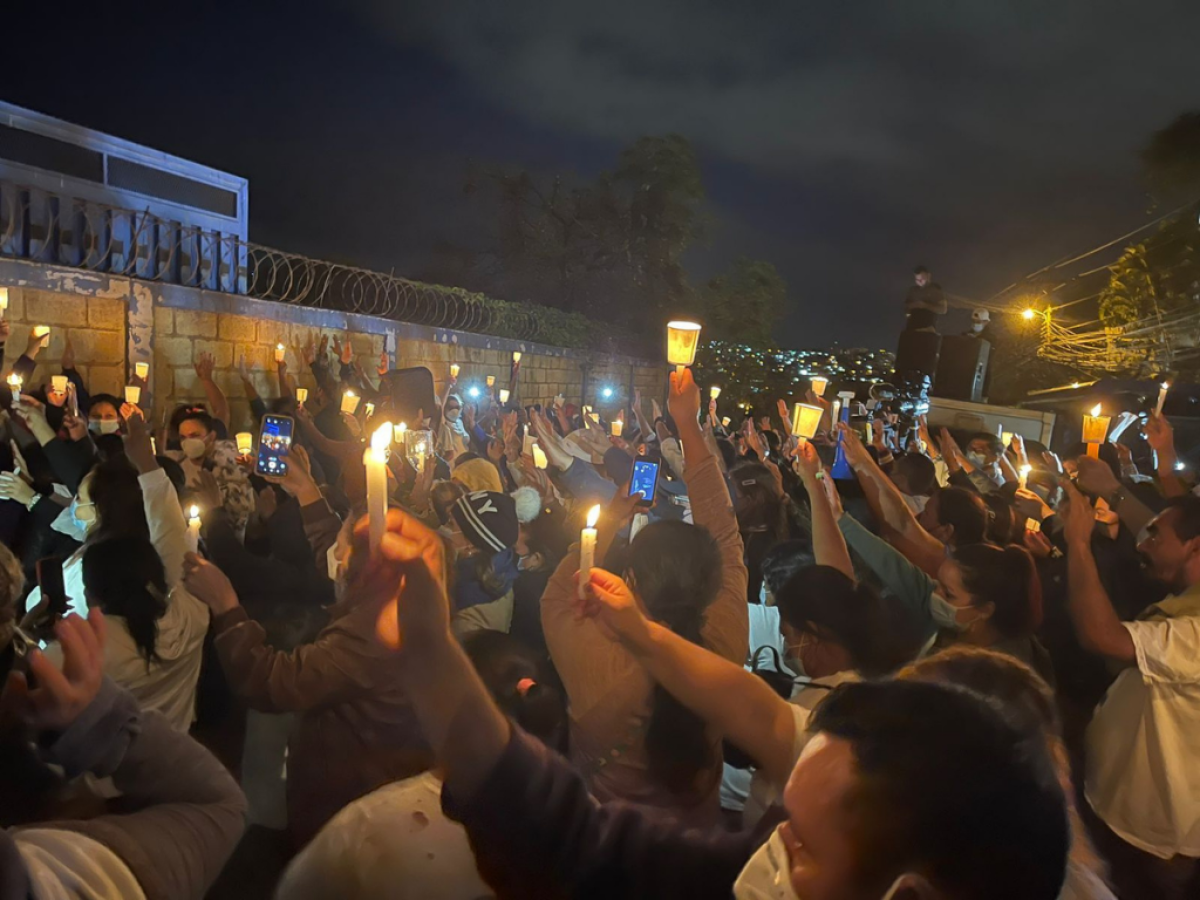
left=0, top=260, right=667, bottom=428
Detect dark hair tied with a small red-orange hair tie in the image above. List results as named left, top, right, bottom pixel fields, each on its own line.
left=462, top=630, right=566, bottom=749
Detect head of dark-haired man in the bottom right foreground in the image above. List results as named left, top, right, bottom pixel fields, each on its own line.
left=739, top=682, right=1070, bottom=900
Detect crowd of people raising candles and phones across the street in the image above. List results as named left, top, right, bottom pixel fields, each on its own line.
left=0, top=323, right=1200, bottom=900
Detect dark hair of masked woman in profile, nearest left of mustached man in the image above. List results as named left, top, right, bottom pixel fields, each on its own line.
left=954, top=544, right=1042, bottom=637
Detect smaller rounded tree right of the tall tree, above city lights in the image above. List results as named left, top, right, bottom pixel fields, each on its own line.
left=702, top=257, right=787, bottom=346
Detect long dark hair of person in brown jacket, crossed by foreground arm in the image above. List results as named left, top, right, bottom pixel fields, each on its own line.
left=629, top=520, right=721, bottom=793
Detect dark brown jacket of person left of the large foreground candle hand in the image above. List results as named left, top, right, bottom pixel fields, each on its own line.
left=215, top=592, right=432, bottom=842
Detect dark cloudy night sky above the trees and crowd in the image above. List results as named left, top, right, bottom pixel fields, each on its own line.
left=0, top=0, right=1200, bottom=347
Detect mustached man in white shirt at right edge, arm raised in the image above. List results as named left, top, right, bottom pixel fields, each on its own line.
left=1066, top=487, right=1200, bottom=900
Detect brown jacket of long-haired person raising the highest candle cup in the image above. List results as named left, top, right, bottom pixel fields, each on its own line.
left=541, top=451, right=750, bottom=826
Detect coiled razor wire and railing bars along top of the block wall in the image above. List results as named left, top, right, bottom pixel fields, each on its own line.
left=0, top=181, right=646, bottom=354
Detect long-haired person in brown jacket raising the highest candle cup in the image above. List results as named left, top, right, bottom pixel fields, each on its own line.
left=540, top=371, right=749, bottom=823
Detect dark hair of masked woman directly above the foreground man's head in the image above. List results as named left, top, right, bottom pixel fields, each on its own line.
left=775, top=565, right=919, bottom=678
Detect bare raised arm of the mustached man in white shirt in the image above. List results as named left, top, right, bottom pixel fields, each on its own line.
left=1060, top=479, right=1136, bottom=666
